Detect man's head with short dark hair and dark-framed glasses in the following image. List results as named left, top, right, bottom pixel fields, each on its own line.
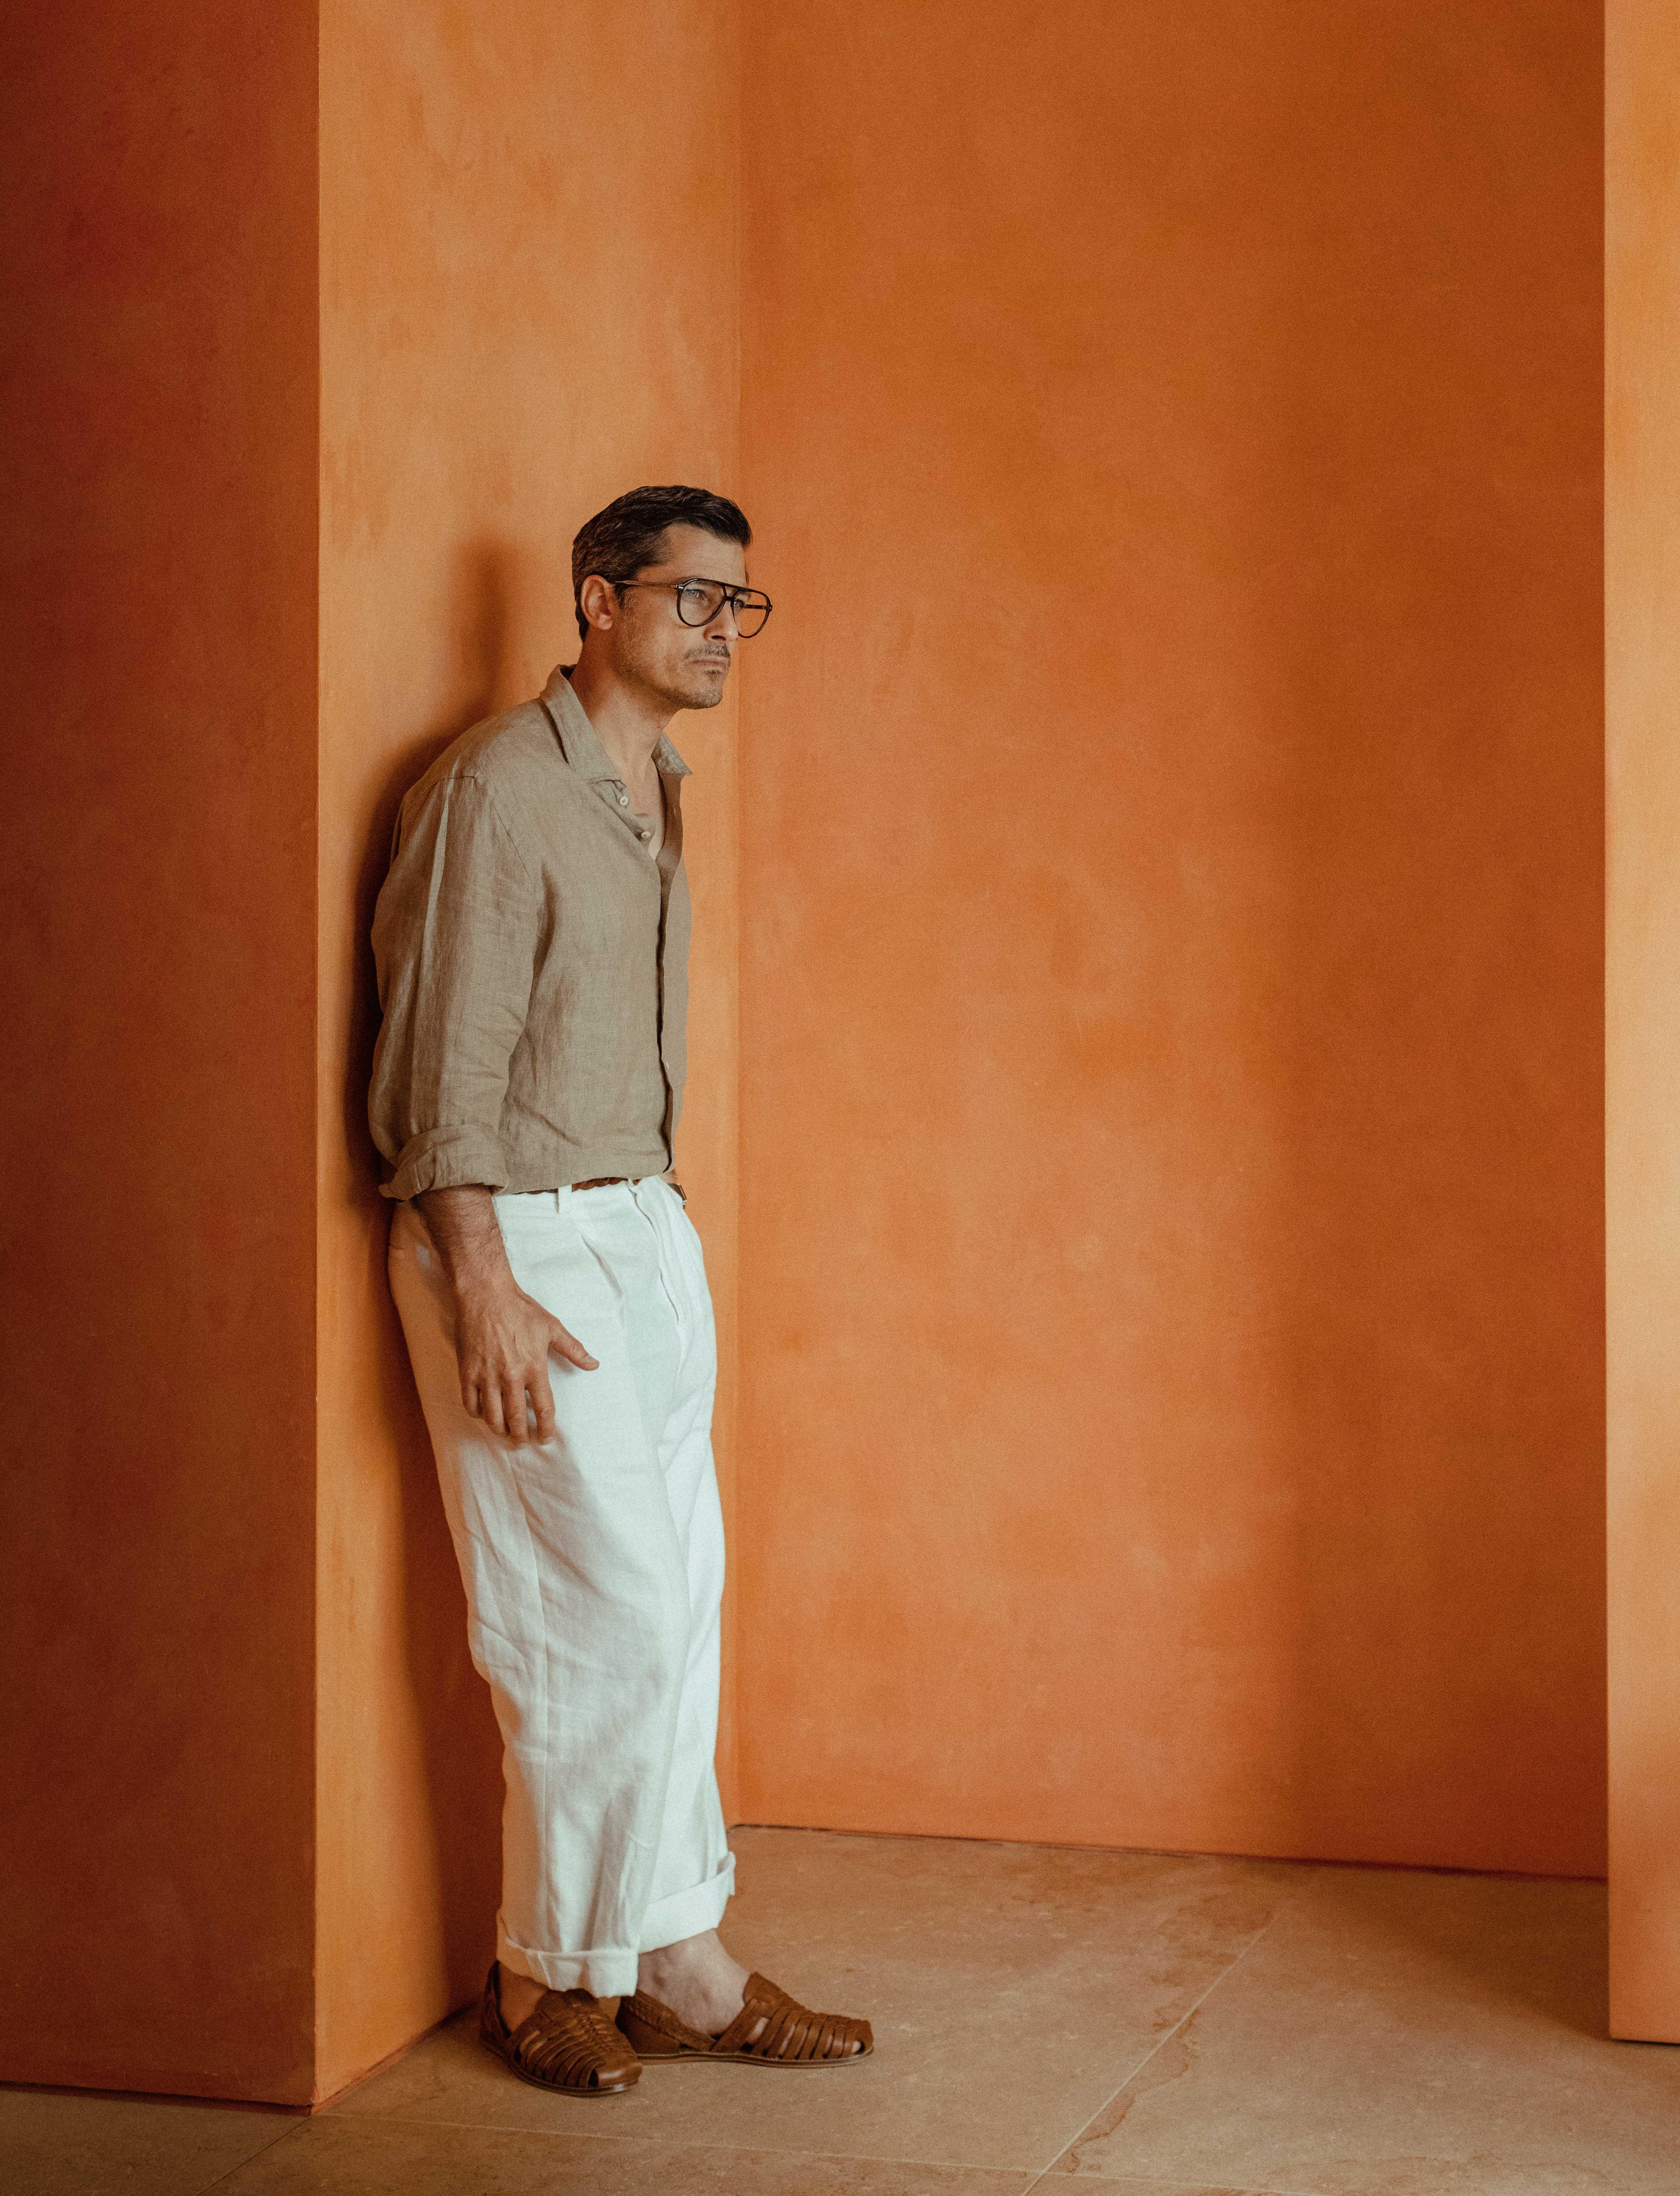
left=571, top=488, right=753, bottom=709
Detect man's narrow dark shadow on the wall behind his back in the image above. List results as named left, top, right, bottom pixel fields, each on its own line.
left=343, top=540, right=525, bottom=2003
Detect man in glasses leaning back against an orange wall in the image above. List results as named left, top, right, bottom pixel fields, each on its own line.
left=369, top=488, right=872, bottom=2095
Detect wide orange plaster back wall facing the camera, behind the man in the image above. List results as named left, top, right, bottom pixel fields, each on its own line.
left=736, top=0, right=1603, bottom=1873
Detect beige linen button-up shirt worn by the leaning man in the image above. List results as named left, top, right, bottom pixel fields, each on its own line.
left=367, top=670, right=692, bottom=1197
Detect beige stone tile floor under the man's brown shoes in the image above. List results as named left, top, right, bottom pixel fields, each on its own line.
left=0, top=1829, right=1680, bottom=2196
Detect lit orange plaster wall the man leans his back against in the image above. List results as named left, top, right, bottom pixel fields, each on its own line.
left=316, top=0, right=738, bottom=2095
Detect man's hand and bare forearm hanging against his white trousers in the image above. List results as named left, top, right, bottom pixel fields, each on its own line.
left=415, top=1184, right=595, bottom=1441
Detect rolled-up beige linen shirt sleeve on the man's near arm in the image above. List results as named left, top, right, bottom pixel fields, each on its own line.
left=367, top=775, right=545, bottom=1199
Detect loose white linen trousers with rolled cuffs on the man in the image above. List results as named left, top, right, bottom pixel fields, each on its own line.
left=391, top=1175, right=736, bottom=1998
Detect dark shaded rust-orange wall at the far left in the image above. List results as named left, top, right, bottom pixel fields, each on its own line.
left=0, top=0, right=316, bottom=2097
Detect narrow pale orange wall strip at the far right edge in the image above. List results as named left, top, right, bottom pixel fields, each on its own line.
left=1605, top=0, right=1680, bottom=2042
